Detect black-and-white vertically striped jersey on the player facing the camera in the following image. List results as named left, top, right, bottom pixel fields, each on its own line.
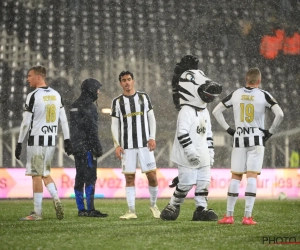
left=110, top=91, right=152, bottom=149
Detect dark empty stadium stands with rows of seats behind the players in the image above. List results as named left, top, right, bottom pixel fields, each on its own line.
left=0, top=0, right=300, bottom=168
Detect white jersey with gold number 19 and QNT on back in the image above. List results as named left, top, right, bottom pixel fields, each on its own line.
left=222, top=87, right=277, bottom=147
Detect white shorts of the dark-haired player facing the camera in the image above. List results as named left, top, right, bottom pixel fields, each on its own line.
left=122, top=147, right=156, bottom=174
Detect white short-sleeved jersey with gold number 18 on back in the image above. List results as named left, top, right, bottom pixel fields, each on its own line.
left=24, top=87, right=63, bottom=146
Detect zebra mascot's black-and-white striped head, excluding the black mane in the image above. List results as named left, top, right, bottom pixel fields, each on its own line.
left=177, top=70, right=222, bottom=109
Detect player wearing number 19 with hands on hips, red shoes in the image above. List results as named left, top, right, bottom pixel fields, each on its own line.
left=213, top=68, right=283, bottom=225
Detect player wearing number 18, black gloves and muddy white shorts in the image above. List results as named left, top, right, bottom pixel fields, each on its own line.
left=15, top=65, right=72, bottom=221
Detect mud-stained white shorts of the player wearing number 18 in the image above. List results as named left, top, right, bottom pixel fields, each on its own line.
left=25, top=146, right=55, bottom=176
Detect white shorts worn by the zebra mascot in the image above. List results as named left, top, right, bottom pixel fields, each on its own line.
left=178, top=165, right=211, bottom=185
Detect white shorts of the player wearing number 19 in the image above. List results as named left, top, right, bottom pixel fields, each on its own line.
left=231, top=146, right=265, bottom=174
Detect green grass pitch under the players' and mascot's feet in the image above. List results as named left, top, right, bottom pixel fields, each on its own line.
left=0, top=199, right=300, bottom=250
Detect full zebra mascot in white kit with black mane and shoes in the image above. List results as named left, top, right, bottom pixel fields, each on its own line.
left=160, top=55, right=222, bottom=221
